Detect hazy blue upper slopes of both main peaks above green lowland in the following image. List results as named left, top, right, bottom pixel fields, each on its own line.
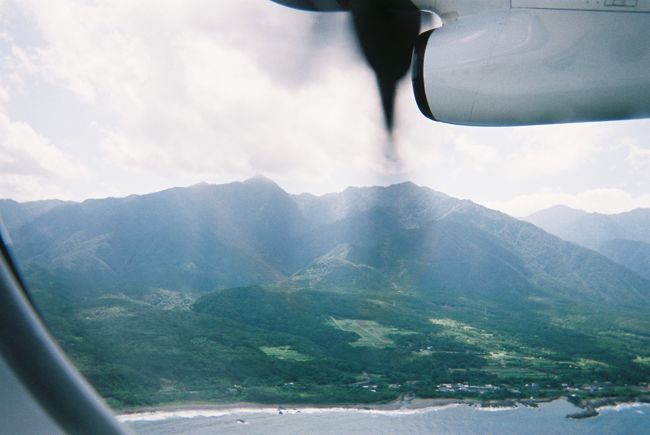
left=6, top=178, right=650, bottom=303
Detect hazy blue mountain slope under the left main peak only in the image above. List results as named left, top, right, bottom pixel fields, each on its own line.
left=7, top=179, right=302, bottom=291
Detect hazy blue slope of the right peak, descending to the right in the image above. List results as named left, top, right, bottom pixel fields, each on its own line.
left=294, top=183, right=648, bottom=302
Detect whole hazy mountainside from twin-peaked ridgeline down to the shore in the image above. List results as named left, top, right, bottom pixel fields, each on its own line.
left=0, top=177, right=650, bottom=407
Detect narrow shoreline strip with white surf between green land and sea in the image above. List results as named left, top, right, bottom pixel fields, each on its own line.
left=115, top=396, right=650, bottom=422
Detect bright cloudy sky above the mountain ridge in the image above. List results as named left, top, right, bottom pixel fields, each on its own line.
left=0, top=0, right=650, bottom=217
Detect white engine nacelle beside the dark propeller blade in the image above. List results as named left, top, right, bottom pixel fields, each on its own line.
left=412, top=8, right=650, bottom=126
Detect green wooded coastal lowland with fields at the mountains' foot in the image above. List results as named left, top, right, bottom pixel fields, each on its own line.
left=33, top=287, right=650, bottom=409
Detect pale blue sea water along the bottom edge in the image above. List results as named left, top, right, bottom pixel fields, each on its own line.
left=122, top=400, right=650, bottom=435
